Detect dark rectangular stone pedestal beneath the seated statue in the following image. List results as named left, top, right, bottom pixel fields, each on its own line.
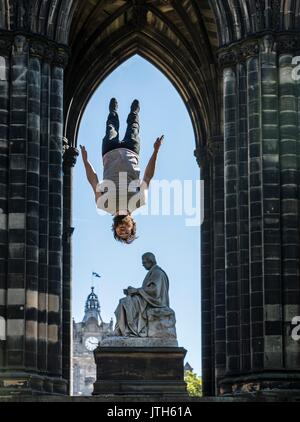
left=93, top=347, right=188, bottom=397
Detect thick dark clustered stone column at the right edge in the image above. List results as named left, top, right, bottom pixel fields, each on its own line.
left=219, top=35, right=300, bottom=394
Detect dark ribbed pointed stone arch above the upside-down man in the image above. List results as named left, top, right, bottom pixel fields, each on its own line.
left=65, top=2, right=220, bottom=155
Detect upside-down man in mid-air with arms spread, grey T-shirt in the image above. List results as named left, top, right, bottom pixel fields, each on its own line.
left=80, top=98, right=164, bottom=244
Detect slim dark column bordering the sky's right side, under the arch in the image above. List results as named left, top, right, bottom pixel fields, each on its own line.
left=195, top=136, right=225, bottom=396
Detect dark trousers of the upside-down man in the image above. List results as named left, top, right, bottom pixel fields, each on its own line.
left=102, top=108, right=140, bottom=156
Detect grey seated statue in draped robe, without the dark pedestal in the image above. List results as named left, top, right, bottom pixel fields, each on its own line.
left=113, top=252, right=176, bottom=339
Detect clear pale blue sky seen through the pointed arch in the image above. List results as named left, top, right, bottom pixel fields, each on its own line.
left=73, top=56, right=201, bottom=374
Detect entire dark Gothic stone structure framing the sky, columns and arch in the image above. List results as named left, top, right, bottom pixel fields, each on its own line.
left=0, top=0, right=300, bottom=396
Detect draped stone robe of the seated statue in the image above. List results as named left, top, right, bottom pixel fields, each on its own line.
left=115, top=265, right=169, bottom=337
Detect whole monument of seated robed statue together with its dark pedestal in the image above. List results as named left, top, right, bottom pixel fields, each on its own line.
left=93, top=252, right=187, bottom=397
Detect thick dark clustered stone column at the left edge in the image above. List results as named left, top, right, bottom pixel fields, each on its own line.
left=0, top=34, right=68, bottom=394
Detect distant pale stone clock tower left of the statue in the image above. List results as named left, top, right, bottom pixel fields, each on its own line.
left=73, top=287, right=113, bottom=396
